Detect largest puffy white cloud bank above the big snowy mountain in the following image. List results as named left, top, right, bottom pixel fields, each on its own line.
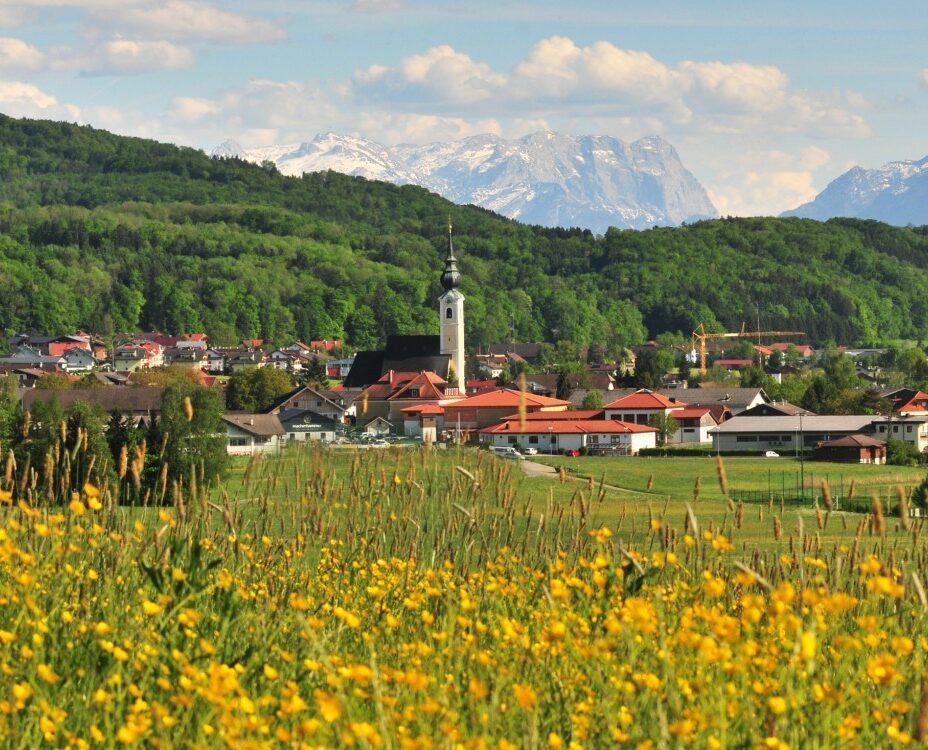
left=346, top=36, right=869, bottom=137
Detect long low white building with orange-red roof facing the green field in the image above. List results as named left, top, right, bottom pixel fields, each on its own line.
left=480, top=412, right=657, bottom=455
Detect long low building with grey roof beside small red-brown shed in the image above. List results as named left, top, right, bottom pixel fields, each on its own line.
left=709, top=414, right=873, bottom=452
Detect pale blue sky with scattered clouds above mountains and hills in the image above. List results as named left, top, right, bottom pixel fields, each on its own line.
left=0, top=0, right=928, bottom=215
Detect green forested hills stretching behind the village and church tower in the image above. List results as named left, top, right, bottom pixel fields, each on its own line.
left=0, top=116, right=928, bottom=347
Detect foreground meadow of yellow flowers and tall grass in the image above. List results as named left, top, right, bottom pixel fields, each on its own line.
left=0, top=448, right=928, bottom=748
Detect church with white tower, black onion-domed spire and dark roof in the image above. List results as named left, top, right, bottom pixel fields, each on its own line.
left=344, top=222, right=466, bottom=396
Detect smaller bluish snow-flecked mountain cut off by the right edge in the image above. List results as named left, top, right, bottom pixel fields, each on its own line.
left=783, top=156, right=928, bottom=225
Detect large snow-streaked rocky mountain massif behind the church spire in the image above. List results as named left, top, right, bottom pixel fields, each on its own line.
left=213, top=132, right=718, bottom=232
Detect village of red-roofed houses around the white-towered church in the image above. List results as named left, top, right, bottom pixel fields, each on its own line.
left=0, top=227, right=928, bottom=464
